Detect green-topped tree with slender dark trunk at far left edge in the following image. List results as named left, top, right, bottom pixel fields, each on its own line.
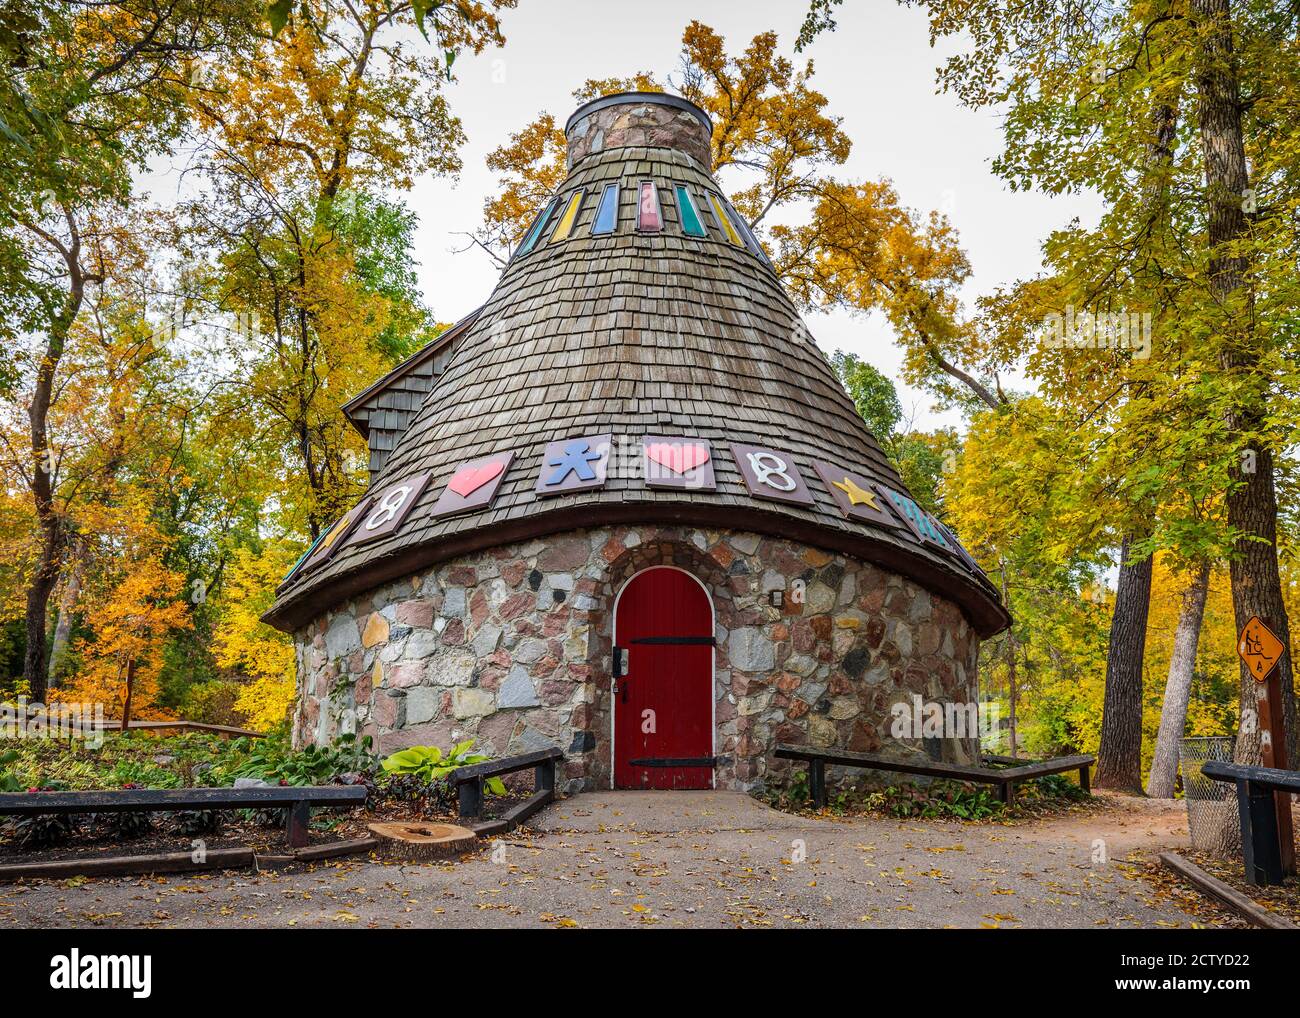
left=0, top=0, right=252, bottom=698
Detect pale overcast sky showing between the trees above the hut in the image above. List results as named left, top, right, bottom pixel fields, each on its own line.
left=142, top=0, right=1099, bottom=429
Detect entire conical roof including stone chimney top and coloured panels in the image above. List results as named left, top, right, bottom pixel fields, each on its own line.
left=265, top=92, right=1009, bottom=636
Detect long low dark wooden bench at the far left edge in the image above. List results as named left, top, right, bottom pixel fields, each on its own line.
left=0, top=785, right=365, bottom=848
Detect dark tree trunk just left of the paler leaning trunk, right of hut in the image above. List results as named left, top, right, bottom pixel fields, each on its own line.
left=1093, top=533, right=1152, bottom=794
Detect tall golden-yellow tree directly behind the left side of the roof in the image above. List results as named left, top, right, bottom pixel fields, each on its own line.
left=189, top=0, right=514, bottom=537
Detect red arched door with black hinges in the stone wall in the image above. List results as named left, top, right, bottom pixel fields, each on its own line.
left=614, top=566, right=714, bottom=788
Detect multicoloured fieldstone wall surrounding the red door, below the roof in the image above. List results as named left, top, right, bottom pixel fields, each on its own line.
left=294, top=527, right=979, bottom=790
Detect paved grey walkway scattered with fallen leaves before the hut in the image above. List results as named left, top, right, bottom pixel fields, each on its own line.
left=0, top=792, right=1192, bottom=927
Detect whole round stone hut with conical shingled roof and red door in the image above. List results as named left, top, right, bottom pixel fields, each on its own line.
left=265, top=94, right=1009, bottom=790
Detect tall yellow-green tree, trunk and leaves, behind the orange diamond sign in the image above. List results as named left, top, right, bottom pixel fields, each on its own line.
left=904, top=0, right=1300, bottom=774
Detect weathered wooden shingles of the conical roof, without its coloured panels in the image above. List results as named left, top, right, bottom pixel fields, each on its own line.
left=267, top=95, right=1008, bottom=634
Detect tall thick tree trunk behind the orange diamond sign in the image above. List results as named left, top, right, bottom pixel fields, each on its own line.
left=1192, top=0, right=1296, bottom=763
